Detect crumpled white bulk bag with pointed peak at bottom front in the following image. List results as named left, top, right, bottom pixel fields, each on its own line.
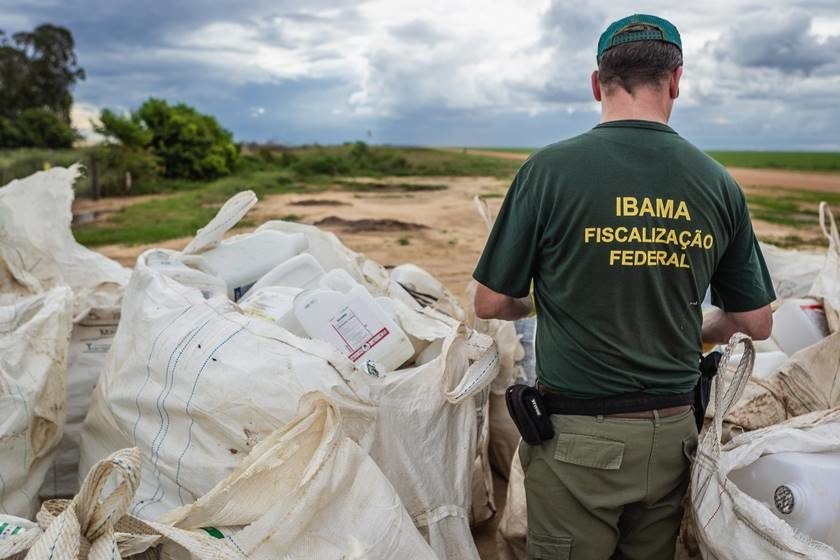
left=13, top=393, right=434, bottom=560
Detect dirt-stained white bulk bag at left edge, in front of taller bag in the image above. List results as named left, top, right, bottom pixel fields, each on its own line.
left=0, top=288, right=73, bottom=517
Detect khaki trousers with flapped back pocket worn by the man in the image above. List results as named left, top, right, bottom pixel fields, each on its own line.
left=519, top=410, right=697, bottom=560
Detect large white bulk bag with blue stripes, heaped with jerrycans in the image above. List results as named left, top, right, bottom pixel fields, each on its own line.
left=82, top=193, right=498, bottom=558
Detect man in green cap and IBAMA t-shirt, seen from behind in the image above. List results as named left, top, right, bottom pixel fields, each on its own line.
left=474, top=15, right=775, bottom=560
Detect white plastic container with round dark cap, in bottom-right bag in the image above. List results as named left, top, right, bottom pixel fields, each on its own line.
left=729, top=452, right=840, bottom=551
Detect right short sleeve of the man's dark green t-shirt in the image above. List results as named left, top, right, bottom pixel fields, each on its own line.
left=711, top=189, right=776, bottom=313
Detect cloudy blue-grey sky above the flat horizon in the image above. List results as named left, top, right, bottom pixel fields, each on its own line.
left=0, top=0, right=840, bottom=150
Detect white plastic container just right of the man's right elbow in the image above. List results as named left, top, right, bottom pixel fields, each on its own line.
left=770, top=298, right=828, bottom=356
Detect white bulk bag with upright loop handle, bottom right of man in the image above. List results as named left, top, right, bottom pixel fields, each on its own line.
left=690, top=334, right=840, bottom=560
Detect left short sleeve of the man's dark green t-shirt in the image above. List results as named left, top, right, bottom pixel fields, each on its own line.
left=473, top=163, right=541, bottom=298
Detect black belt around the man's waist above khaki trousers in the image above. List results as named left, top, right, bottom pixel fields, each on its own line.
left=538, top=383, right=694, bottom=416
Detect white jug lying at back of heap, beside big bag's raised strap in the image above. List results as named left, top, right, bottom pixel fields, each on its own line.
left=183, top=230, right=309, bottom=301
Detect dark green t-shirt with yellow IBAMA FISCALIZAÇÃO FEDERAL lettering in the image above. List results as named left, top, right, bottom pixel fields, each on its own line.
left=474, top=120, right=775, bottom=398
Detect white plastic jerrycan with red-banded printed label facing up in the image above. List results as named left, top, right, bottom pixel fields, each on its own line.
left=294, top=269, right=414, bottom=375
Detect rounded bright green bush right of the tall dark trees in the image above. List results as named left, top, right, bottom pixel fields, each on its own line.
left=136, top=98, right=239, bottom=179
